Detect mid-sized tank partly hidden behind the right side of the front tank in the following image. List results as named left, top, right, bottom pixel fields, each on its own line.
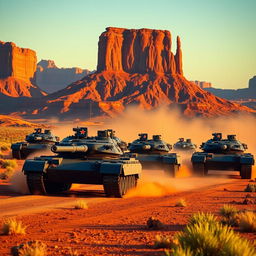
left=128, top=133, right=180, bottom=177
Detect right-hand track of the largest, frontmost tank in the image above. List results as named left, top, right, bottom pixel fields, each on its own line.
left=103, top=175, right=137, bottom=197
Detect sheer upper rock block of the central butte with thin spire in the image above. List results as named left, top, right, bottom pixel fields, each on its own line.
left=97, top=27, right=183, bottom=75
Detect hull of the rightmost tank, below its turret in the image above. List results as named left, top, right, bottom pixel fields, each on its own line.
left=191, top=152, right=255, bottom=179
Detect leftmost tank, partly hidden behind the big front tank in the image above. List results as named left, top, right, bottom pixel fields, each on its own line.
left=11, top=128, right=59, bottom=159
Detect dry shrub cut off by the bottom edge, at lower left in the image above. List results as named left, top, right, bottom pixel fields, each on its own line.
left=11, top=241, right=46, bottom=256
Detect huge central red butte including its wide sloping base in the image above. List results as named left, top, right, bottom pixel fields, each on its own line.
left=18, top=28, right=253, bottom=118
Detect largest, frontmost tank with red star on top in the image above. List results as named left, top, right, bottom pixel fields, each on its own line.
left=23, top=127, right=142, bottom=197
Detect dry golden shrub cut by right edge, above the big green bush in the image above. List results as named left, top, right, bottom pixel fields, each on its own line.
left=238, top=211, right=256, bottom=232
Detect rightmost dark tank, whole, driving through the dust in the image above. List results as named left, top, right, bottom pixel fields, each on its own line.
left=191, top=133, right=254, bottom=179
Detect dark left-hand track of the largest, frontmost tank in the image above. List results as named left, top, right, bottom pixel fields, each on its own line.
left=27, top=173, right=46, bottom=195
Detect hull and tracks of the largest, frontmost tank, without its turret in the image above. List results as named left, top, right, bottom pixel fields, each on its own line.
left=23, top=157, right=142, bottom=197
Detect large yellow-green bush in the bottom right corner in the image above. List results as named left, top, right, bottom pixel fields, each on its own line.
left=176, top=222, right=256, bottom=256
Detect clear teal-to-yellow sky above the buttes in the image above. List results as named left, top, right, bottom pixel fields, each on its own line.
left=0, top=0, right=256, bottom=89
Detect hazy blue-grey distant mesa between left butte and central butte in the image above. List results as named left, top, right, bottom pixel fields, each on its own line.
left=36, top=60, right=90, bottom=93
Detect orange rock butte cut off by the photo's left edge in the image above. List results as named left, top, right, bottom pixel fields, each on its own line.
left=0, top=41, right=44, bottom=97
